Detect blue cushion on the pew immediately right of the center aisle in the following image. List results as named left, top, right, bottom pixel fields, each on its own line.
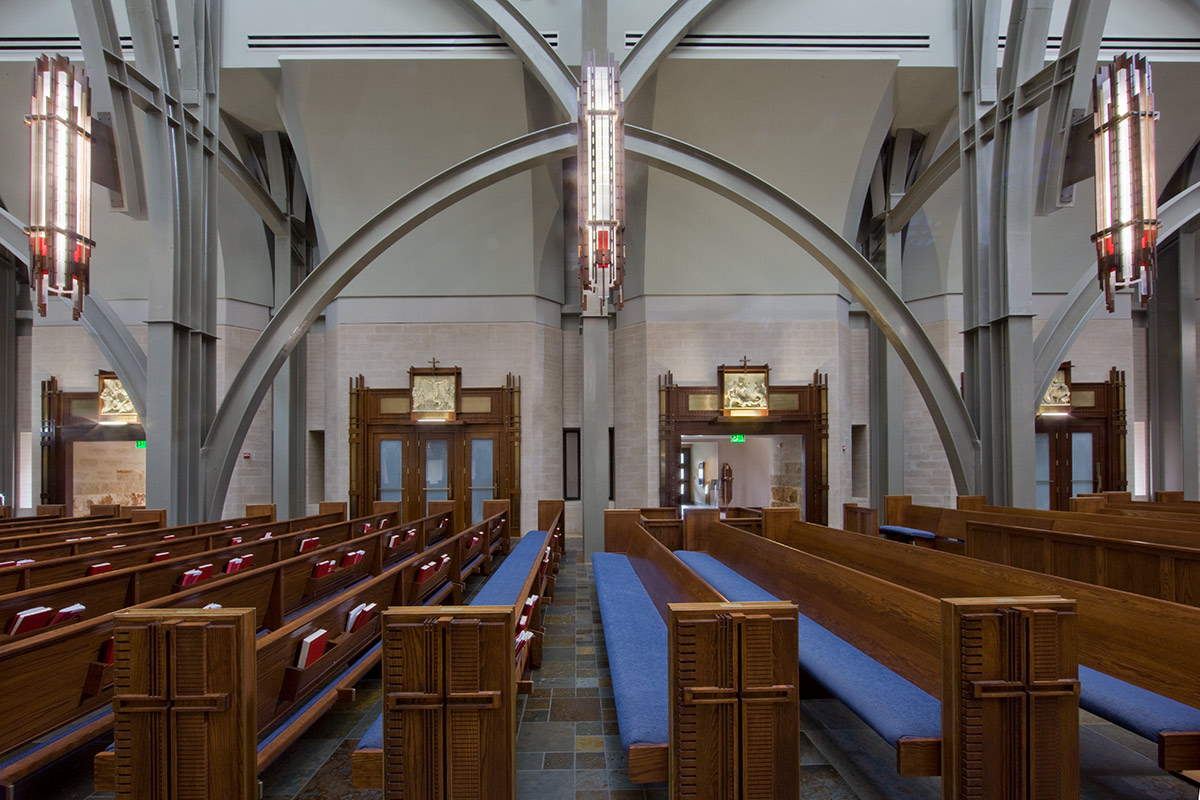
left=592, top=553, right=671, bottom=748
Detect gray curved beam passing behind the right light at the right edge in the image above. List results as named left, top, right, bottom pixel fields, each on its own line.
left=1031, top=184, right=1200, bottom=409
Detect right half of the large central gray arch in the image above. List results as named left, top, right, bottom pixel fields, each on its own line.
left=625, top=126, right=979, bottom=494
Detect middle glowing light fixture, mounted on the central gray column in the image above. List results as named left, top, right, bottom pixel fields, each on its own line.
left=578, top=53, right=625, bottom=317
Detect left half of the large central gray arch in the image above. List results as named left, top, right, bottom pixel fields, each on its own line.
left=200, top=122, right=577, bottom=519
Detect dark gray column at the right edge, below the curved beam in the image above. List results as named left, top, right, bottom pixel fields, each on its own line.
left=1147, top=227, right=1200, bottom=500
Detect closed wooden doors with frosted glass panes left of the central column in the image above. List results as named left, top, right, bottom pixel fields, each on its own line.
left=368, top=426, right=508, bottom=524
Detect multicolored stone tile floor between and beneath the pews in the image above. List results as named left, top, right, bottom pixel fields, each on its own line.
left=63, top=537, right=1198, bottom=800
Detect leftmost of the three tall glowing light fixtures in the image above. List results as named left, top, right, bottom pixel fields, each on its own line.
left=25, top=55, right=96, bottom=319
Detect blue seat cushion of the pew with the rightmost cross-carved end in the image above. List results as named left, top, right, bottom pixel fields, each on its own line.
left=676, top=551, right=942, bottom=746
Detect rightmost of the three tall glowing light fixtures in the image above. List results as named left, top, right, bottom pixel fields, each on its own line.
left=1092, top=54, right=1159, bottom=312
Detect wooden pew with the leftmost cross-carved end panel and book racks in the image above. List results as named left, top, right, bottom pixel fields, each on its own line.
left=85, top=501, right=508, bottom=800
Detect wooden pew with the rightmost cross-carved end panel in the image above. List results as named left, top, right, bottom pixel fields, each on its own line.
left=686, top=512, right=1079, bottom=799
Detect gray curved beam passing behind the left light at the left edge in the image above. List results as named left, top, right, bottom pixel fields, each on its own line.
left=0, top=209, right=146, bottom=420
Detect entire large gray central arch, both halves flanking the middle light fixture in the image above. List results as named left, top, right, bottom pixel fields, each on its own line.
left=202, top=122, right=979, bottom=518
